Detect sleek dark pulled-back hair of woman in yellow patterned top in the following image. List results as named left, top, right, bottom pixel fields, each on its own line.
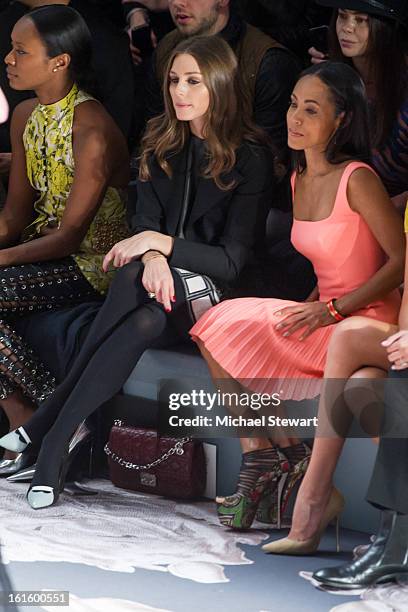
left=26, top=4, right=95, bottom=93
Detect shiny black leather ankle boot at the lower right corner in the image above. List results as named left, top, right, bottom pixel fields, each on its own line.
left=313, top=510, right=408, bottom=589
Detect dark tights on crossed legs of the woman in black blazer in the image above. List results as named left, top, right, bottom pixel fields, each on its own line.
left=24, top=262, right=191, bottom=487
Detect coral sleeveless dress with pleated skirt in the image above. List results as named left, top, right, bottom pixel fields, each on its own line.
left=190, top=162, right=401, bottom=400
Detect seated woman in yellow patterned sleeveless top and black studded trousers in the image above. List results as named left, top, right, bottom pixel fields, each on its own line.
left=0, top=5, right=129, bottom=467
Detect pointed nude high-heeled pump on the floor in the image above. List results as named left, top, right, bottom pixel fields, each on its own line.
left=262, top=487, right=344, bottom=555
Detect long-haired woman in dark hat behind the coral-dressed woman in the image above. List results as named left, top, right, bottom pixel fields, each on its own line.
left=311, top=0, right=408, bottom=213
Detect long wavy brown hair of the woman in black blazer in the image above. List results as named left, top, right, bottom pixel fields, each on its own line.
left=139, top=36, right=266, bottom=190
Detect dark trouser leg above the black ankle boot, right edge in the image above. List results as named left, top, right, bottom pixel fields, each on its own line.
left=367, top=370, right=408, bottom=514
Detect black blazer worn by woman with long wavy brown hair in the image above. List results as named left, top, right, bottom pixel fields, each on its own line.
left=131, top=143, right=275, bottom=287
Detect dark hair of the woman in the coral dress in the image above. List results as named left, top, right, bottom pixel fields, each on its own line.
left=293, top=62, right=371, bottom=172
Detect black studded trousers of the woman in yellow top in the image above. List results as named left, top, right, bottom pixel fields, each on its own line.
left=0, top=257, right=101, bottom=402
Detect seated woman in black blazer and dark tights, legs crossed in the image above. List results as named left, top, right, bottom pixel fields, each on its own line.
left=0, top=36, right=273, bottom=508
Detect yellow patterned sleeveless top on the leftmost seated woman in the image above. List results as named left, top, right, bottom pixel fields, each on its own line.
left=23, top=84, right=128, bottom=294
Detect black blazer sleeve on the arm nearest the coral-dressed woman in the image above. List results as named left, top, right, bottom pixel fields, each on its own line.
left=169, top=146, right=274, bottom=285
